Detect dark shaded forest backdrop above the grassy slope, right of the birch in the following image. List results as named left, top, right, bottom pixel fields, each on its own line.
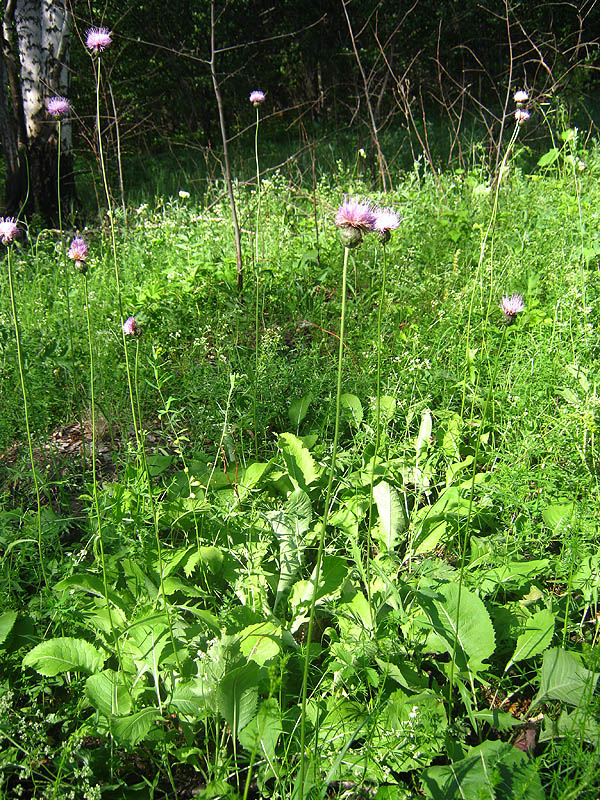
left=2, top=0, right=600, bottom=217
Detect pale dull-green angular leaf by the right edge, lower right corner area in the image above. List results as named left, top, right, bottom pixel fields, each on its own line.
left=530, top=647, right=600, bottom=710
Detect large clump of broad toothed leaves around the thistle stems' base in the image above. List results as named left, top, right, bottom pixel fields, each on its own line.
left=7, top=394, right=598, bottom=798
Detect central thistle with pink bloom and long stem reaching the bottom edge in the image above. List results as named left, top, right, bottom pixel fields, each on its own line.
left=298, top=198, right=376, bottom=797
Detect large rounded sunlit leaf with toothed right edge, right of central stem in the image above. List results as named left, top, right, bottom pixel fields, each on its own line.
left=419, top=583, right=496, bottom=672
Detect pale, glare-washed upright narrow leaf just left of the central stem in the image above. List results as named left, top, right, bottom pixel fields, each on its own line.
left=267, top=489, right=312, bottom=608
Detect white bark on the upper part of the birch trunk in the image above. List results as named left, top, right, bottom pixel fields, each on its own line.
left=15, top=0, right=71, bottom=153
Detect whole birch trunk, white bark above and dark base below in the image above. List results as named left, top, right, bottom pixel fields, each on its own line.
left=0, top=0, right=75, bottom=223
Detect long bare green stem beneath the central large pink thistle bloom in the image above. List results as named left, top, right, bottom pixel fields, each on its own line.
left=298, top=247, right=350, bottom=798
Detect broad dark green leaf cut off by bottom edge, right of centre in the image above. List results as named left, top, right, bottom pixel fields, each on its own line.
left=422, top=741, right=545, bottom=800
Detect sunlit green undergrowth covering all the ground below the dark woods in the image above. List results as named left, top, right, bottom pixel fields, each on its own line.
left=0, top=128, right=600, bottom=800
